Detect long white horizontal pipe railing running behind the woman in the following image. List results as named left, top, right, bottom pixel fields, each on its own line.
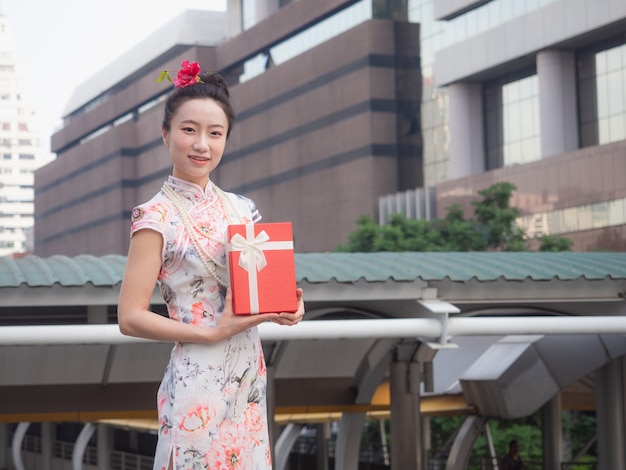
left=0, top=316, right=626, bottom=346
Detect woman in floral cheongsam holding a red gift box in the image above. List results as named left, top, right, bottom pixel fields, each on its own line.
left=118, top=61, right=304, bottom=470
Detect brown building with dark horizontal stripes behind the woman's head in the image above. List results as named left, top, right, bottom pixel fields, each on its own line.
left=35, top=0, right=421, bottom=256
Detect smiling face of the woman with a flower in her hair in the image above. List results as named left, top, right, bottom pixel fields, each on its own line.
left=162, top=98, right=228, bottom=188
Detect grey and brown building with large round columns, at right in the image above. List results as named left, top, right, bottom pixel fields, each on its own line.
left=426, top=0, right=626, bottom=251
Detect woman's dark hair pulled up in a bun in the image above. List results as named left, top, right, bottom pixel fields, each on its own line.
left=161, top=73, right=235, bottom=138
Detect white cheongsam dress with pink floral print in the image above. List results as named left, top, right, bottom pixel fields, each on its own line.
left=131, top=176, right=271, bottom=470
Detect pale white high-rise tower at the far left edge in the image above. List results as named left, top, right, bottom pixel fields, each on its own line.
left=0, top=11, right=47, bottom=256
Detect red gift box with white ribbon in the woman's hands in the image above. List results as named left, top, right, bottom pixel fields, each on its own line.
left=226, top=222, right=298, bottom=315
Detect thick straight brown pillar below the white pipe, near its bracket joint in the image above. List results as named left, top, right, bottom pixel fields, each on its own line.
left=389, top=361, right=424, bottom=470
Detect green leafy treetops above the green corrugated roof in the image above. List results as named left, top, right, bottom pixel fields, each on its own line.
left=335, top=182, right=572, bottom=253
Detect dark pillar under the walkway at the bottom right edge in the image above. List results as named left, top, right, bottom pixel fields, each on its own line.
left=595, top=358, right=626, bottom=470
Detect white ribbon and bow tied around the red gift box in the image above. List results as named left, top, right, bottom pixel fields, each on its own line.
left=229, top=224, right=293, bottom=314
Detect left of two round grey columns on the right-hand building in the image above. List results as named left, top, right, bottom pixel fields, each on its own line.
left=447, top=83, right=485, bottom=179
